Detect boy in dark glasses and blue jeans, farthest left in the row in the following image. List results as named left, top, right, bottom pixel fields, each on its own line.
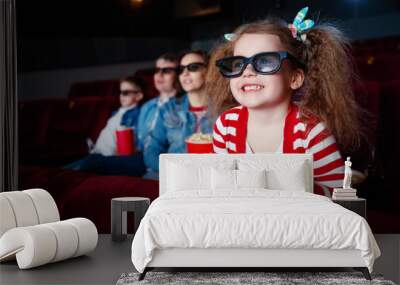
left=65, top=77, right=145, bottom=176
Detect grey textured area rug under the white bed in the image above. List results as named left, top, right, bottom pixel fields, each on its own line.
left=117, top=272, right=395, bottom=285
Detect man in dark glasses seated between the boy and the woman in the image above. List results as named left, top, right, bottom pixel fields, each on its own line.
left=138, top=53, right=178, bottom=150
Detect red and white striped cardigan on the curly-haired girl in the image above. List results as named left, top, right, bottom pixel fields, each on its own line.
left=213, top=104, right=344, bottom=196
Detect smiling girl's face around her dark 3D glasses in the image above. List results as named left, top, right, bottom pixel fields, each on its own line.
left=230, top=34, right=292, bottom=108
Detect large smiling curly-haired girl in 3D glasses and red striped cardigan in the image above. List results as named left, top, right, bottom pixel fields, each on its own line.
left=211, top=8, right=362, bottom=196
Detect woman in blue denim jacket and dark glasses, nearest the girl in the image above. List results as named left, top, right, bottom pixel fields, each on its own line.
left=143, top=51, right=213, bottom=177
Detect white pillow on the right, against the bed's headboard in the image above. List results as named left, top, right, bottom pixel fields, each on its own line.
left=238, top=160, right=310, bottom=192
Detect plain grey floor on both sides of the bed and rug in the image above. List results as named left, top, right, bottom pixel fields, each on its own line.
left=0, top=234, right=400, bottom=285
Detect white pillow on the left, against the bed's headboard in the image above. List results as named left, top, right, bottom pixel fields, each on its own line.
left=167, top=160, right=235, bottom=191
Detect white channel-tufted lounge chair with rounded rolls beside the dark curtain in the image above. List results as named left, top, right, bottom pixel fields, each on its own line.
left=0, top=189, right=98, bottom=269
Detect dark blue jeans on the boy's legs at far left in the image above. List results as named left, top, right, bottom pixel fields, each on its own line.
left=64, top=152, right=146, bottom=177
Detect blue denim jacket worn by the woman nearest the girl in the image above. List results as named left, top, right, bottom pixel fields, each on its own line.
left=143, top=94, right=213, bottom=172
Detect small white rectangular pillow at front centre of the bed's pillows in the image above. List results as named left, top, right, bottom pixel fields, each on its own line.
left=211, top=168, right=267, bottom=191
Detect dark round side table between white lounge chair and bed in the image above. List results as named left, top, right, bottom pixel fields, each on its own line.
left=111, top=197, right=150, bottom=241
